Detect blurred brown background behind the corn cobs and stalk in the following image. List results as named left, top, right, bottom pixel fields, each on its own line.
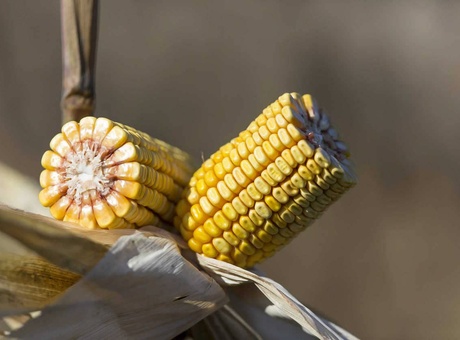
left=0, top=0, right=460, bottom=339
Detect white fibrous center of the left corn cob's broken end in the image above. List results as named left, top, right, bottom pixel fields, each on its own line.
left=64, top=141, right=113, bottom=204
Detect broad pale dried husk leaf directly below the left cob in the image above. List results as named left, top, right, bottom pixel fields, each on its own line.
left=12, top=233, right=227, bottom=339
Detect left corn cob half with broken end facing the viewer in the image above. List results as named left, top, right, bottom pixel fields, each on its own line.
left=39, top=117, right=193, bottom=229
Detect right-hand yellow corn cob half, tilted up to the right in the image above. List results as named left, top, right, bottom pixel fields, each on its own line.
left=174, top=93, right=356, bottom=267
